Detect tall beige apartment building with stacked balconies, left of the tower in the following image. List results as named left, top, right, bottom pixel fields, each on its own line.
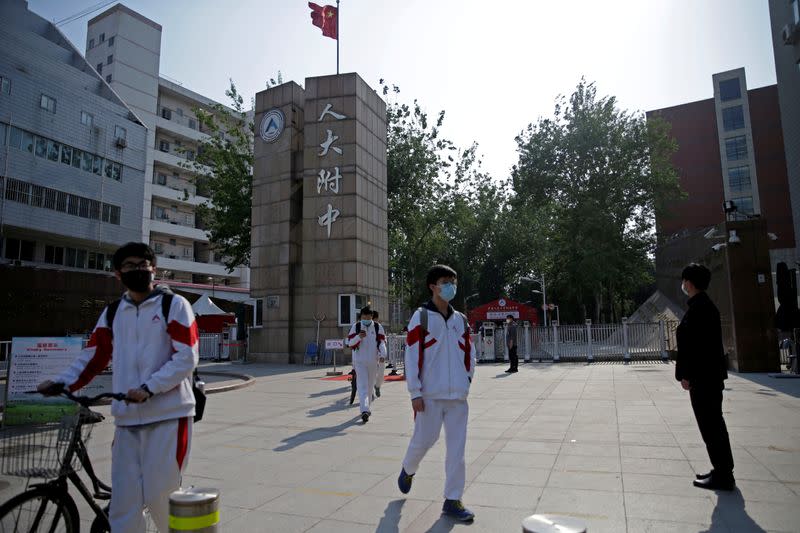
left=86, top=4, right=249, bottom=294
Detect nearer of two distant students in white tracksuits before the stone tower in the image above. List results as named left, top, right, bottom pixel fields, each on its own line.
left=347, top=306, right=386, bottom=424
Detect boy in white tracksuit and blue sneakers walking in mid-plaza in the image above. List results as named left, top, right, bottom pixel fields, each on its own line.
left=397, top=265, right=476, bottom=522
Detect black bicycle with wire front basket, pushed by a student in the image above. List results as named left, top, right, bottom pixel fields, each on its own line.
left=0, top=389, right=156, bottom=533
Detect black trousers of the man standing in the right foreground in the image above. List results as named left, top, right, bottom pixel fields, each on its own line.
left=689, top=386, right=733, bottom=477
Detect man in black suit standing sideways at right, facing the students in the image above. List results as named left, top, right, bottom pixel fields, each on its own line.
left=675, top=263, right=736, bottom=490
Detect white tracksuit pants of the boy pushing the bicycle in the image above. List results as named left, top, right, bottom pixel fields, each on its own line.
left=109, top=417, right=192, bottom=533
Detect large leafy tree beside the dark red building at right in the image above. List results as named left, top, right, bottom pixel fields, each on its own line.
left=512, top=79, right=681, bottom=322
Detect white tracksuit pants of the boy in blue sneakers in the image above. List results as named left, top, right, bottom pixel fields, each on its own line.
left=403, top=399, right=469, bottom=500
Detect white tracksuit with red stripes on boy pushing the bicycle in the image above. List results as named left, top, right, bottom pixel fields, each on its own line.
left=54, top=289, right=198, bottom=533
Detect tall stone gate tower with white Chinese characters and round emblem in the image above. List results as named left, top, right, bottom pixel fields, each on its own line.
left=249, top=73, right=389, bottom=363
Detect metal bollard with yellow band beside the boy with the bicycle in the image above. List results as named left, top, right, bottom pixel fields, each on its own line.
left=169, top=487, right=219, bottom=533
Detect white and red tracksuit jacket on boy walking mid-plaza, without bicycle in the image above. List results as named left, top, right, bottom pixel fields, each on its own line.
left=405, top=302, right=476, bottom=400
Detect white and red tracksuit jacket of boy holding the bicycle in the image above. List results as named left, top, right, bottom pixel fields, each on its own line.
left=54, top=289, right=199, bottom=426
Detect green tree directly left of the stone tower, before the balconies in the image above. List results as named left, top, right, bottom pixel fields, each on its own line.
left=184, top=80, right=253, bottom=272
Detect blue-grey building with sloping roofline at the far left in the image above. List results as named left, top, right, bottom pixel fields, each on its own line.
left=0, top=0, right=147, bottom=270
